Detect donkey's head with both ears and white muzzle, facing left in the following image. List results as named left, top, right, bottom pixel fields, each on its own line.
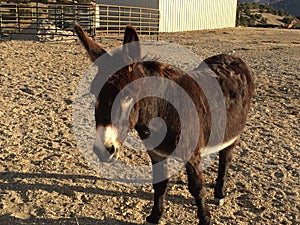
left=74, top=24, right=141, bottom=162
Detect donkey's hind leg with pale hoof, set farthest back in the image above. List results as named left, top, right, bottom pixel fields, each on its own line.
left=214, top=141, right=238, bottom=206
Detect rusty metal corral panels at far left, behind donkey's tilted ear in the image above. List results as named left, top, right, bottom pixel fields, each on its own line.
left=0, top=2, right=96, bottom=39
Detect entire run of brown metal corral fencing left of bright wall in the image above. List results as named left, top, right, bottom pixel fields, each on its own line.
left=0, top=1, right=159, bottom=39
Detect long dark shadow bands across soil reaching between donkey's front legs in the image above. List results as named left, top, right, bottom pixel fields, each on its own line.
left=0, top=172, right=197, bottom=205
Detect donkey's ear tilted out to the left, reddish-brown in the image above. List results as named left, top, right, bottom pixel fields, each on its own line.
left=74, top=24, right=106, bottom=61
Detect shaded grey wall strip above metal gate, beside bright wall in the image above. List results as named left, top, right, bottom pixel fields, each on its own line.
left=95, top=0, right=159, bottom=9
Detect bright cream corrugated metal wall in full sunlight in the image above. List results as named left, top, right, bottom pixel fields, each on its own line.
left=159, top=0, right=237, bottom=32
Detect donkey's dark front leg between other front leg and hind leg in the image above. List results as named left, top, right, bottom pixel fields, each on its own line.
left=185, top=162, right=210, bottom=225
